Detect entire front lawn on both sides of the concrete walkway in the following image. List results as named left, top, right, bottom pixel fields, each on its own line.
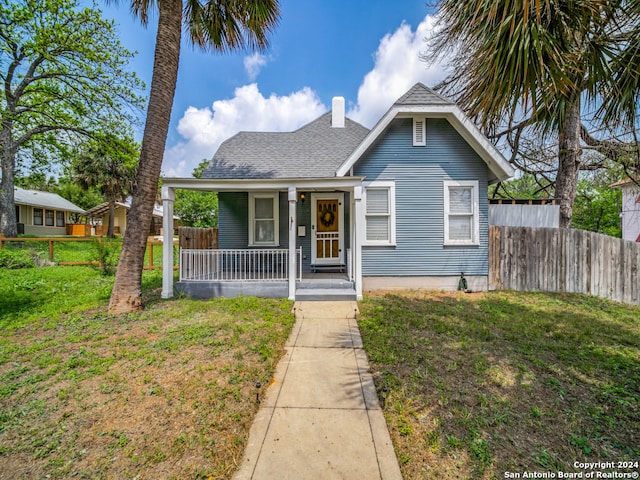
left=0, top=267, right=640, bottom=480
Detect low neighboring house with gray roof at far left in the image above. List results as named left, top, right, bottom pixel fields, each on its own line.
left=14, top=187, right=85, bottom=237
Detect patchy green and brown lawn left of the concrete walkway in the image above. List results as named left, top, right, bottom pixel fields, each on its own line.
left=0, top=267, right=294, bottom=479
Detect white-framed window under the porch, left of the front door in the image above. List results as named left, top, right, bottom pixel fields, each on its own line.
left=249, top=192, right=280, bottom=246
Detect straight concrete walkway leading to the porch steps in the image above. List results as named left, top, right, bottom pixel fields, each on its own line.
left=234, top=302, right=402, bottom=480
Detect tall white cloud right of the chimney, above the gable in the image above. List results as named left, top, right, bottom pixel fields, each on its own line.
left=347, top=15, right=446, bottom=127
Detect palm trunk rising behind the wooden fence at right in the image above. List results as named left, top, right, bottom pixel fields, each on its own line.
left=556, top=99, right=582, bottom=228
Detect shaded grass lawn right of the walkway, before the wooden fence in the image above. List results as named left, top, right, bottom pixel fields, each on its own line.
left=359, top=292, right=640, bottom=479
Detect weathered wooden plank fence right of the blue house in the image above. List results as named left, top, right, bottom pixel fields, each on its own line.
left=489, top=226, right=640, bottom=305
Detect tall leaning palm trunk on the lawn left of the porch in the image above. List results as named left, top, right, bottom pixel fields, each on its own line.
left=109, top=0, right=182, bottom=314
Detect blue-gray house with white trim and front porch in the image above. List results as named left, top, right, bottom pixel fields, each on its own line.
left=162, top=84, right=513, bottom=299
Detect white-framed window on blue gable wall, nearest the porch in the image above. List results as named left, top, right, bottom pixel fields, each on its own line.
left=364, top=181, right=396, bottom=245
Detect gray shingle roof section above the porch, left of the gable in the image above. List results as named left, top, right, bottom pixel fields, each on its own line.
left=202, top=112, right=369, bottom=179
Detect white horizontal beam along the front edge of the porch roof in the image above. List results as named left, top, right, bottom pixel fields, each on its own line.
left=162, top=177, right=365, bottom=192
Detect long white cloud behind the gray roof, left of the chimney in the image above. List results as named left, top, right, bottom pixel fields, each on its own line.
left=162, top=83, right=327, bottom=177
